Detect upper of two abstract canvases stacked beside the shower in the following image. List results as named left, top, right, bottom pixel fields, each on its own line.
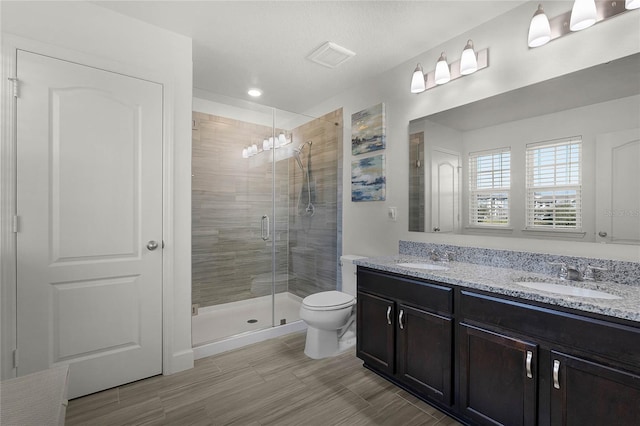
left=351, top=103, right=386, bottom=155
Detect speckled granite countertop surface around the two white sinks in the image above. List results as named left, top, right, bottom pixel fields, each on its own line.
left=354, top=255, right=640, bottom=322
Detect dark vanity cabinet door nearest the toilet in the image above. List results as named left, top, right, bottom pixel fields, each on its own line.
left=356, top=292, right=396, bottom=374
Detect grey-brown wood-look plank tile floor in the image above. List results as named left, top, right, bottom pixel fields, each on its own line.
left=66, top=333, right=459, bottom=426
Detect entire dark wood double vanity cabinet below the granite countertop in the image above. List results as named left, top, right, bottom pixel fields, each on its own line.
left=357, top=267, right=640, bottom=426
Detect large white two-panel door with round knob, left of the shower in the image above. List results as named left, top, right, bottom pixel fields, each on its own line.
left=16, top=51, right=162, bottom=398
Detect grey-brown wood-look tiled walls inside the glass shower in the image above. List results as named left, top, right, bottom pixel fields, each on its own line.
left=192, top=110, right=342, bottom=307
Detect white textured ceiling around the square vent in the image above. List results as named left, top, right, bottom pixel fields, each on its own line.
left=95, top=0, right=523, bottom=112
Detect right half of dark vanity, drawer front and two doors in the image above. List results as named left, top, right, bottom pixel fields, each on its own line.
left=456, top=290, right=640, bottom=426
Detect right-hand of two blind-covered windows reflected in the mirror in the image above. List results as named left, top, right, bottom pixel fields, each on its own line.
left=527, top=137, right=582, bottom=230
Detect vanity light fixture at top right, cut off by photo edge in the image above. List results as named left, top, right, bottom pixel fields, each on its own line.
left=527, top=0, right=640, bottom=48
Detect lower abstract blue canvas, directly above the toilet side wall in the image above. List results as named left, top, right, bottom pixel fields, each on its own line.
left=351, top=155, right=386, bottom=201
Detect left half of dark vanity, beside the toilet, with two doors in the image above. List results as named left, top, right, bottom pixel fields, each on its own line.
left=356, top=268, right=453, bottom=406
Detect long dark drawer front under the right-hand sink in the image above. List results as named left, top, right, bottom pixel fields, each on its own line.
left=460, top=290, right=640, bottom=371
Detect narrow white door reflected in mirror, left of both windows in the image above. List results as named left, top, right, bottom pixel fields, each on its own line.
left=431, top=148, right=460, bottom=233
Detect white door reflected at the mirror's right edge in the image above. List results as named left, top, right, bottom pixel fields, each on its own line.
left=596, top=129, right=640, bottom=244
